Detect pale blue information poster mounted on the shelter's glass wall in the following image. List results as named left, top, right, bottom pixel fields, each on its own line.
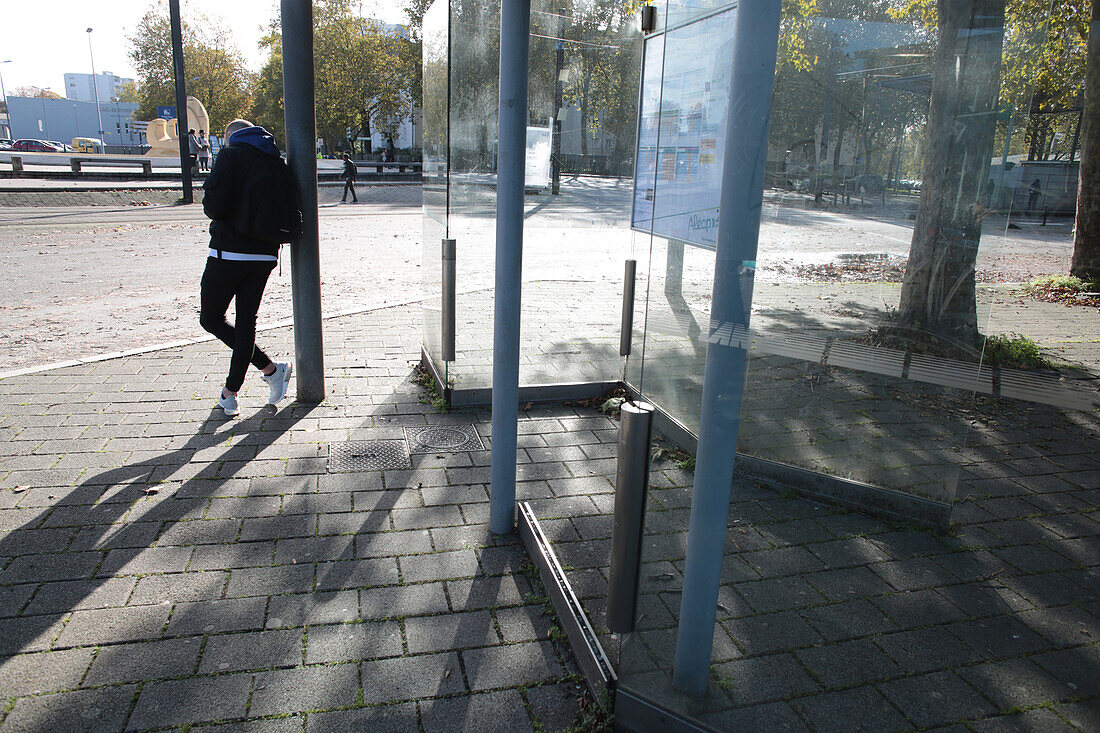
left=631, top=9, right=737, bottom=249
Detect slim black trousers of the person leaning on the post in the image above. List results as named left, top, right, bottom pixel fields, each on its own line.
left=199, top=258, right=275, bottom=392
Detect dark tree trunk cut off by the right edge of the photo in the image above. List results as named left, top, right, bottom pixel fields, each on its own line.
left=1069, top=0, right=1100, bottom=280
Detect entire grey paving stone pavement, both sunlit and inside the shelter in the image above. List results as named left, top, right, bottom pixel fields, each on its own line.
left=0, top=294, right=1100, bottom=732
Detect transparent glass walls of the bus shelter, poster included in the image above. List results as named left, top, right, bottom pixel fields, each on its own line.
left=422, top=0, right=1100, bottom=730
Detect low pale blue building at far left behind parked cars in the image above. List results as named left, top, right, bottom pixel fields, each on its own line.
left=8, top=97, right=145, bottom=153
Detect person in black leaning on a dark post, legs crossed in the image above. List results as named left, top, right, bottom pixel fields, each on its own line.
left=199, top=125, right=292, bottom=416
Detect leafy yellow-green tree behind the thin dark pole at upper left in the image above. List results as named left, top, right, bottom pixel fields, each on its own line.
left=129, top=0, right=254, bottom=133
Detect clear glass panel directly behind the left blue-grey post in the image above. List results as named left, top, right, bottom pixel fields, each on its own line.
left=425, top=0, right=640, bottom=390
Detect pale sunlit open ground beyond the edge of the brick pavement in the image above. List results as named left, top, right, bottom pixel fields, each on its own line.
left=0, top=178, right=1071, bottom=371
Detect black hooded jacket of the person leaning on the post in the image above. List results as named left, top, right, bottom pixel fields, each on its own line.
left=202, top=127, right=279, bottom=256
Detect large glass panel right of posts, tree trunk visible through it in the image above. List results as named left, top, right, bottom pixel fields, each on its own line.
left=738, top=9, right=1002, bottom=503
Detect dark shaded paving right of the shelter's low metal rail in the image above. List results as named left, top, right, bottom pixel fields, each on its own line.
left=546, top=396, right=1100, bottom=730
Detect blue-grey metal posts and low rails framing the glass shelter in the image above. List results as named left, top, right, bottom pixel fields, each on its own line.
left=422, top=0, right=780, bottom=730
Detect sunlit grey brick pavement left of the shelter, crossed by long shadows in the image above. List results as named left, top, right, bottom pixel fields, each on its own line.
left=0, top=307, right=614, bottom=732
